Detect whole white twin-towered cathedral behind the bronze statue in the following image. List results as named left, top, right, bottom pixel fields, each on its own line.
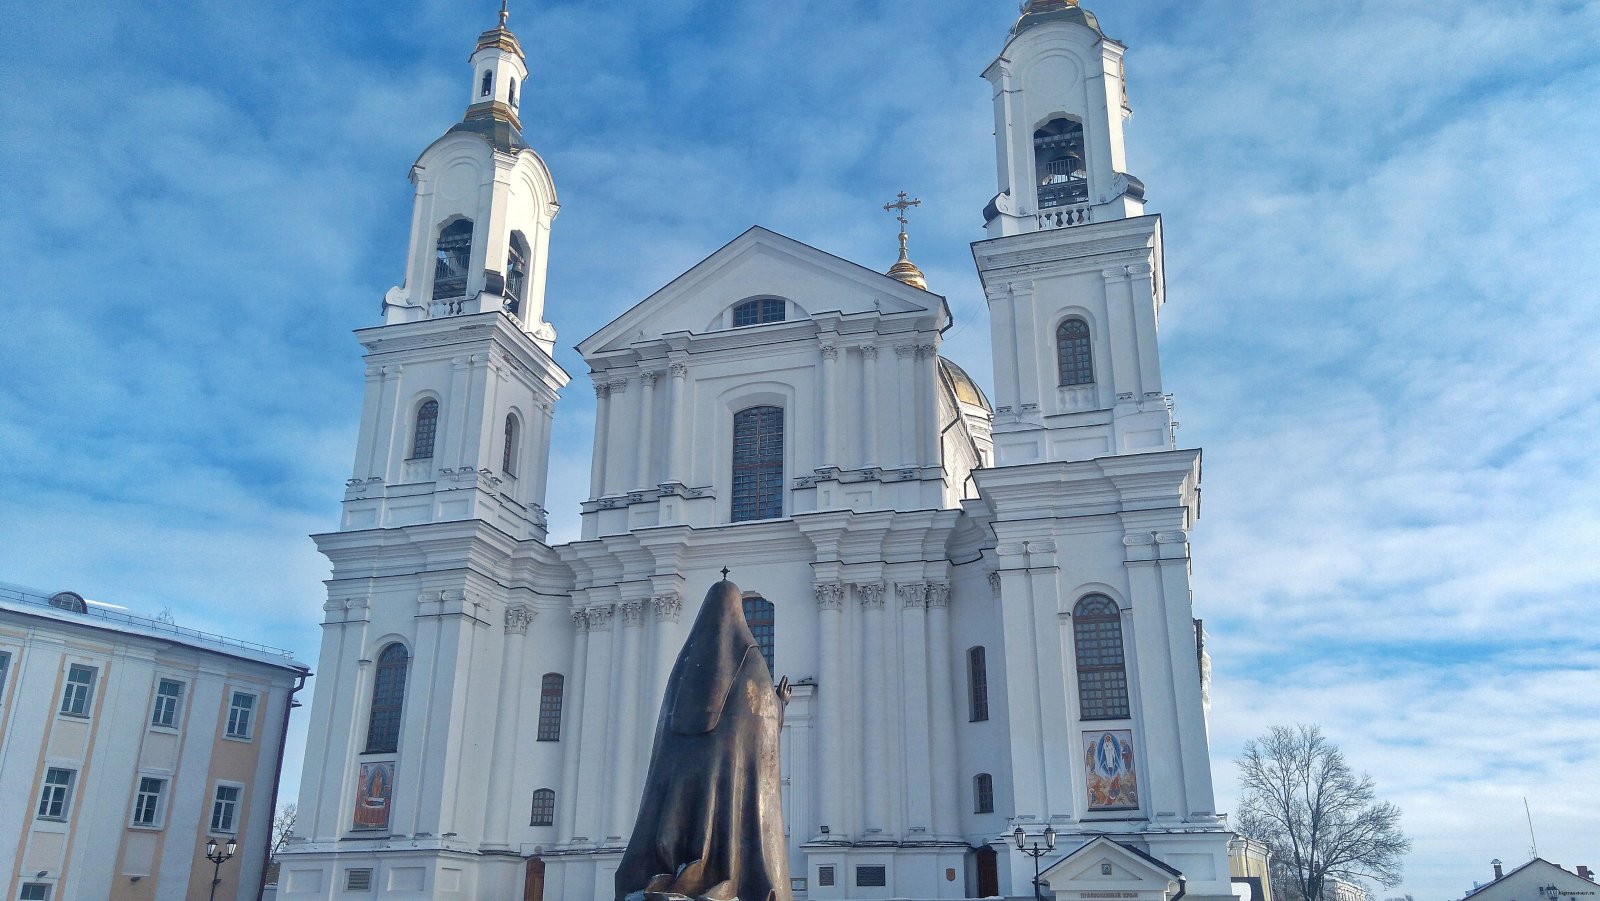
left=278, top=0, right=1232, bottom=901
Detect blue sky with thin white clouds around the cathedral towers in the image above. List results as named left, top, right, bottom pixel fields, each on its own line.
left=0, top=0, right=1600, bottom=901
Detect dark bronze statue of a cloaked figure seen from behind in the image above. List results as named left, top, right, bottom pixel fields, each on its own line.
left=616, top=579, right=794, bottom=901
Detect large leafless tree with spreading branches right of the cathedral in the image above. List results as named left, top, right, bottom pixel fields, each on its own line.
left=1237, top=725, right=1411, bottom=901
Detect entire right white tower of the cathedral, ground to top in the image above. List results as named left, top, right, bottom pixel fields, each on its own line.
left=973, top=0, right=1230, bottom=901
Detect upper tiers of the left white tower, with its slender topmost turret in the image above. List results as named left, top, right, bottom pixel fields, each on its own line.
left=342, top=5, right=568, bottom=539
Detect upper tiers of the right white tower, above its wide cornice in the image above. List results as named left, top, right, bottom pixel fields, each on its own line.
left=973, top=0, right=1174, bottom=466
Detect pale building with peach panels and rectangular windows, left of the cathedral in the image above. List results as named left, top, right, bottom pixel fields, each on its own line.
left=0, top=586, right=309, bottom=901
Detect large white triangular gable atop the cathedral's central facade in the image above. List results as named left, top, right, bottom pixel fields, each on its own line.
left=578, top=226, right=949, bottom=357
